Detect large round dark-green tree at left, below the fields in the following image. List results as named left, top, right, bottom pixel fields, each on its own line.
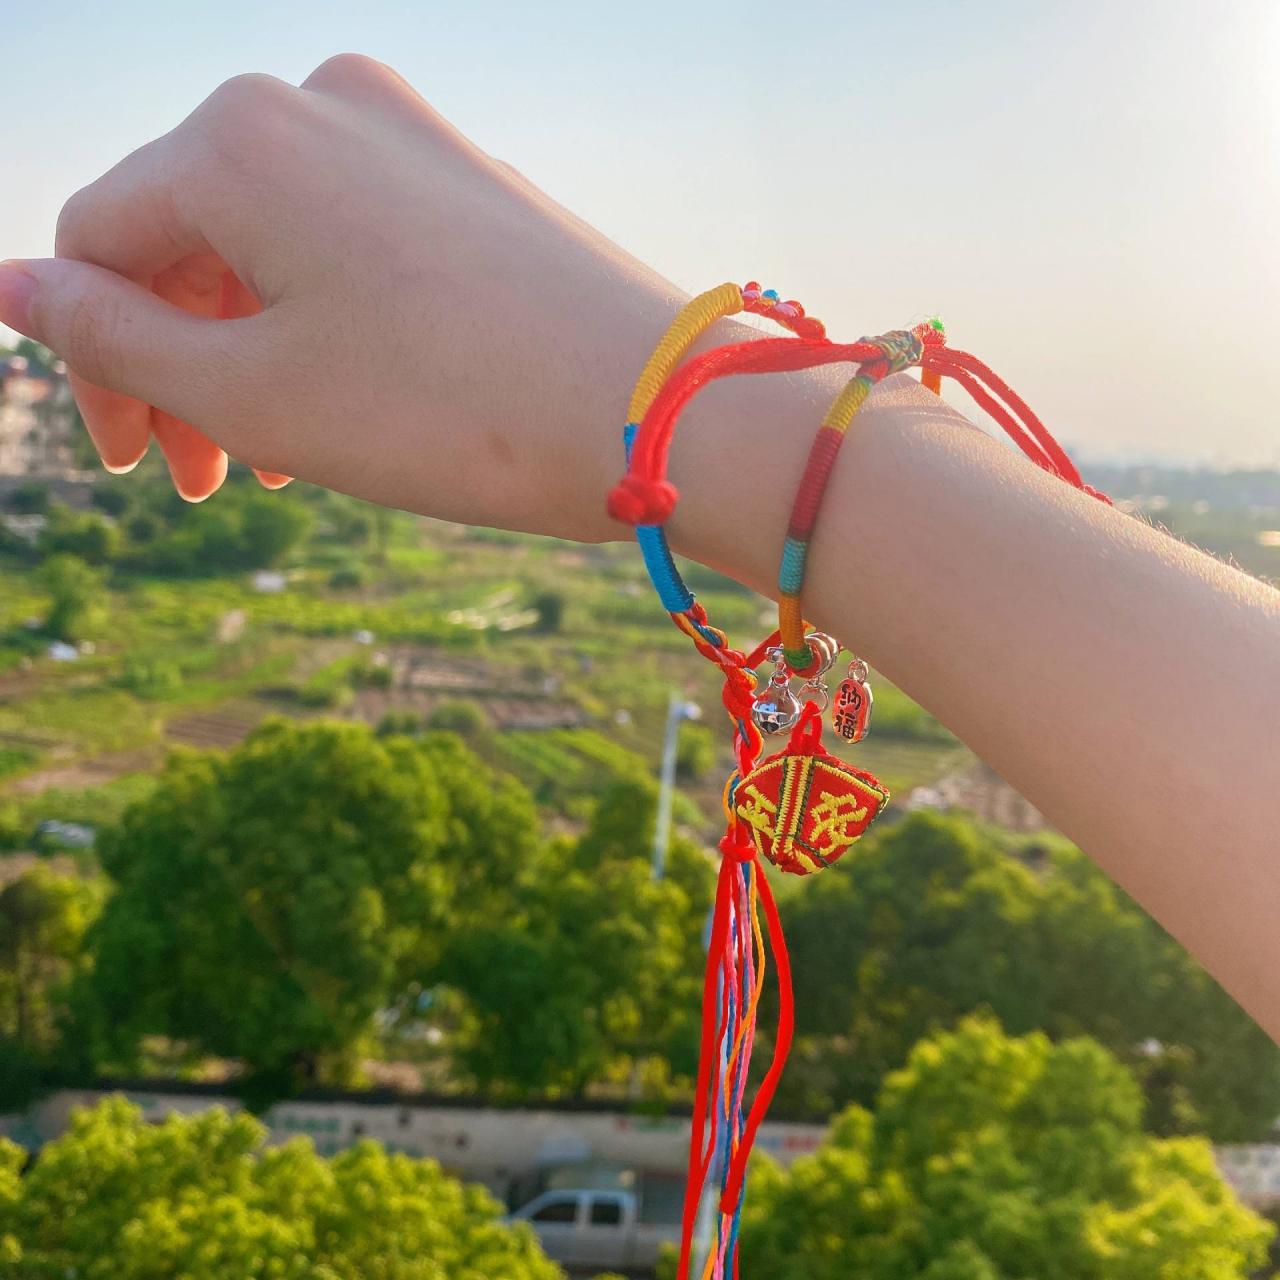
left=78, top=722, right=538, bottom=1100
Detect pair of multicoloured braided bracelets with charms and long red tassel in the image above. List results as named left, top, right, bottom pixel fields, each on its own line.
left=608, top=284, right=1106, bottom=1280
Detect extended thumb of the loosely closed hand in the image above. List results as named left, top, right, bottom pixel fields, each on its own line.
left=0, top=257, right=253, bottom=430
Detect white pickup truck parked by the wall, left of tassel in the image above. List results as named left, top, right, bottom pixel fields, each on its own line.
left=511, top=1190, right=680, bottom=1275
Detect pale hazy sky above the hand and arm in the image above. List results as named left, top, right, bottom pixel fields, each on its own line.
left=0, top=0, right=1280, bottom=465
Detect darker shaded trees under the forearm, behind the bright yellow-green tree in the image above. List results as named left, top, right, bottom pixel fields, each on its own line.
left=781, top=814, right=1280, bottom=1140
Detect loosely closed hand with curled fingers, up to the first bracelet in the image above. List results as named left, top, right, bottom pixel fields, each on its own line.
left=0, top=55, right=675, bottom=538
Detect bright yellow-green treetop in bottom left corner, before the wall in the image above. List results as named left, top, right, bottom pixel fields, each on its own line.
left=0, top=1098, right=562, bottom=1280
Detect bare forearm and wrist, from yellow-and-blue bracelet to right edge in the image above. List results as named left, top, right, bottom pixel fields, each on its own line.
left=672, top=343, right=1280, bottom=1037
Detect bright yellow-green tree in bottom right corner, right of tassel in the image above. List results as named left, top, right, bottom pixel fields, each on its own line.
left=742, top=1018, right=1274, bottom=1280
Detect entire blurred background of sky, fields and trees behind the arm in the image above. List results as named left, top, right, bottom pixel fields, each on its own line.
left=0, top=0, right=1280, bottom=1280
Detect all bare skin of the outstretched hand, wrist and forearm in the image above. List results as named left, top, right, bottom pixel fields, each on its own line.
left=0, top=55, right=1280, bottom=1037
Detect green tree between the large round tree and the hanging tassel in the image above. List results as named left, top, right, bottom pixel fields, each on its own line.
left=444, top=783, right=712, bottom=1094
